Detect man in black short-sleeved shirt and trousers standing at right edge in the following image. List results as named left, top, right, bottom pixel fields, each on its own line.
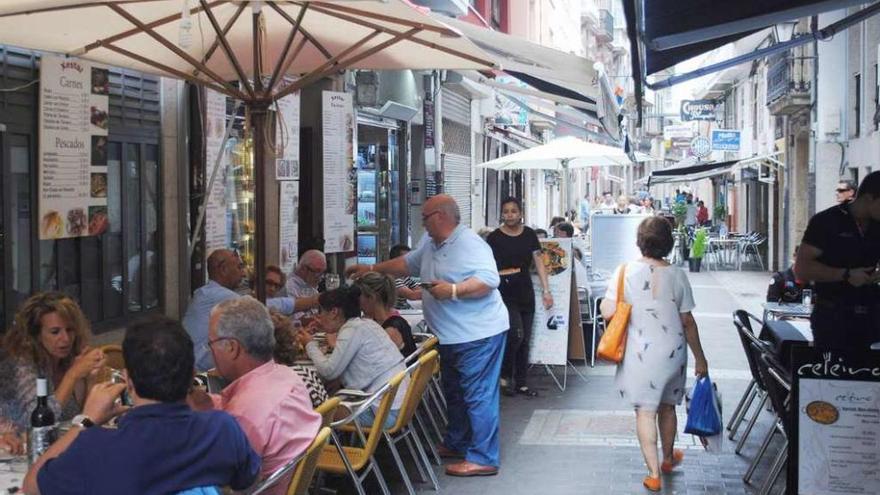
left=795, top=171, right=880, bottom=349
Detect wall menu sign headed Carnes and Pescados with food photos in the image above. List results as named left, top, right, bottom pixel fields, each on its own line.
left=39, top=55, right=110, bottom=239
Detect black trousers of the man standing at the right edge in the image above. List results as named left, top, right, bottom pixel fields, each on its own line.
left=810, top=304, right=880, bottom=350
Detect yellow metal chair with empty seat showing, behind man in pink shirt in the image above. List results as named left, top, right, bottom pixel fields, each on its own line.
left=318, top=371, right=406, bottom=495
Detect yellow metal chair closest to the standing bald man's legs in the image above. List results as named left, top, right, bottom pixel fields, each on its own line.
left=344, top=351, right=440, bottom=495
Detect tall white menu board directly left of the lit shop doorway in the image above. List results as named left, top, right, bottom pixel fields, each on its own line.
left=322, top=91, right=357, bottom=254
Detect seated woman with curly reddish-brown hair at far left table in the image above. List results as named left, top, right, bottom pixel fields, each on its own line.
left=0, top=292, right=105, bottom=431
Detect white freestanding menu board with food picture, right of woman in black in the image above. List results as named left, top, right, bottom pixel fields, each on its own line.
left=529, top=239, right=574, bottom=366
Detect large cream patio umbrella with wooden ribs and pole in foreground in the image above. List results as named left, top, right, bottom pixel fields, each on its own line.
left=0, top=0, right=495, bottom=300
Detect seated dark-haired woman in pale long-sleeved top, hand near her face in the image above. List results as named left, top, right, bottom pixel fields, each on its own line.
left=296, top=286, right=409, bottom=427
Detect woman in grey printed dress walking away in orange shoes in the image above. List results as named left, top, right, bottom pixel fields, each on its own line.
left=601, top=217, right=708, bottom=491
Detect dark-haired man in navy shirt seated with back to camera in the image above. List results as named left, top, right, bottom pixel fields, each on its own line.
left=24, top=317, right=260, bottom=495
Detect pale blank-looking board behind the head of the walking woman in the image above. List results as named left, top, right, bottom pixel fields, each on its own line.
left=590, top=214, right=645, bottom=277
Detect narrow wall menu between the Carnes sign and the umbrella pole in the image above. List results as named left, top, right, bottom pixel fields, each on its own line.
left=204, top=89, right=229, bottom=253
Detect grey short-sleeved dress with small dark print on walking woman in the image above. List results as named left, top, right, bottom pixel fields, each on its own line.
left=605, top=261, right=694, bottom=410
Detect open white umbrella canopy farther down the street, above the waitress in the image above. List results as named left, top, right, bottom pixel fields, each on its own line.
left=478, top=137, right=652, bottom=170
